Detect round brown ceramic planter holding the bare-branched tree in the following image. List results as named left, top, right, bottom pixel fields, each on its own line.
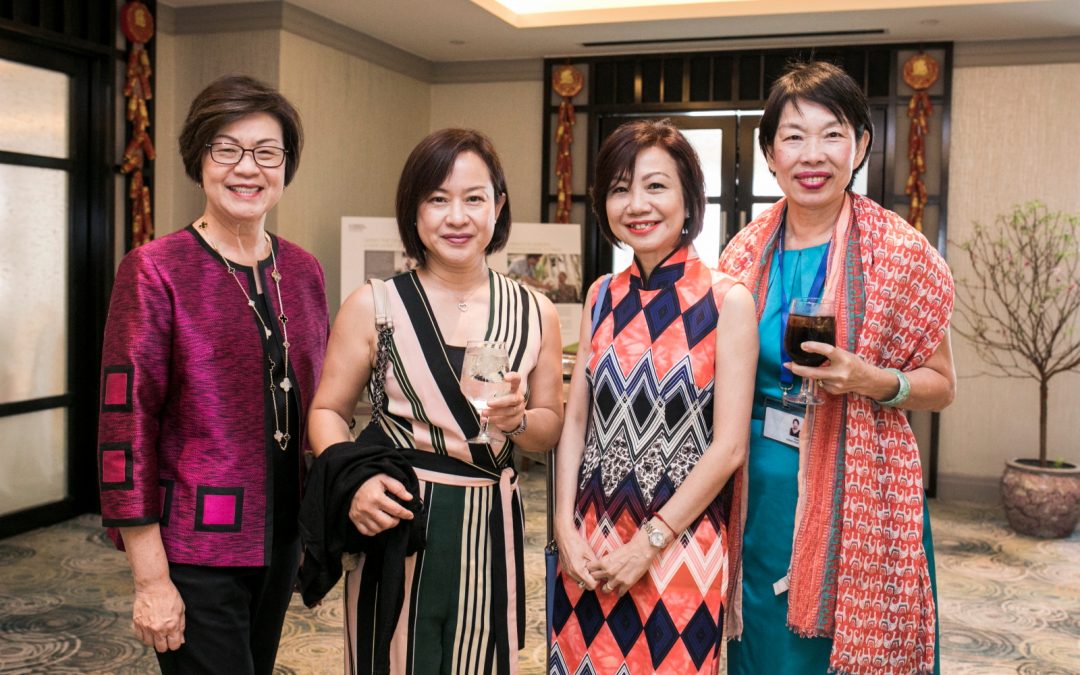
left=1001, top=459, right=1080, bottom=538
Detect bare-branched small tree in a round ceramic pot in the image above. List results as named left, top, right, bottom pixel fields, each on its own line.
left=955, top=202, right=1080, bottom=537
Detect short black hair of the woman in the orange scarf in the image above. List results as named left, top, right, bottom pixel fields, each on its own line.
left=757, top=60, right=874, bottom=190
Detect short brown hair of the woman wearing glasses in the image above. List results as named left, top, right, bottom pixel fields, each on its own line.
left=179, top=75, right=303, bottom=185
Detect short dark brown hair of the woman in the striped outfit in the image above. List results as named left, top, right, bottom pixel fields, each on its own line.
left=396, top=129, right=511, bottom=265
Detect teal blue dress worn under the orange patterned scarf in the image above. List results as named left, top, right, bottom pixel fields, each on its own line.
left=728, top=244, right=940, bottom=675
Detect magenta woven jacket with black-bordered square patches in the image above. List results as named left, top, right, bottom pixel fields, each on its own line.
left=97, top=226, right=329, bottom=566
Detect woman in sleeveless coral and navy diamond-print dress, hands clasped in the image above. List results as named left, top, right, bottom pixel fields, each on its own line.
left=550, top=121, right=757, bottom=675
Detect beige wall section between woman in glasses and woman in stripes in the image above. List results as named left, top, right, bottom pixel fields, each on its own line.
left=278, top=32, right=430, bottom=315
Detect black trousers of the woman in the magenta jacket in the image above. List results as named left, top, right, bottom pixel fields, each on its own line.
left=158, top=538, right=300, bottom=675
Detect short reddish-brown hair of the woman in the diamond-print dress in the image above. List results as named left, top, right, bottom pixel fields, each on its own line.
left=592, top=119, right=705, bottom=246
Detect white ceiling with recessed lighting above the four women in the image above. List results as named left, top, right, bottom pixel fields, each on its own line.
left=161, top=0, right=1080, bottom=62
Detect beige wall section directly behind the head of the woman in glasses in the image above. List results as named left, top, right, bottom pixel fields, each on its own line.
left=154, top=30, right=281, bottom=237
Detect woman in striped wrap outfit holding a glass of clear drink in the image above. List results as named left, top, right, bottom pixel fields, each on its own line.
left=310, top=130, right=563, bottom=675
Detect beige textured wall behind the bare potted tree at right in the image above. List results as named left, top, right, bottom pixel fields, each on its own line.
left=940, top=64, right=1080, bottom=498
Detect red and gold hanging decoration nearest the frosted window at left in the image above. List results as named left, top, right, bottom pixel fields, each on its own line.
left=120, top=0, right=154, bottom=248
